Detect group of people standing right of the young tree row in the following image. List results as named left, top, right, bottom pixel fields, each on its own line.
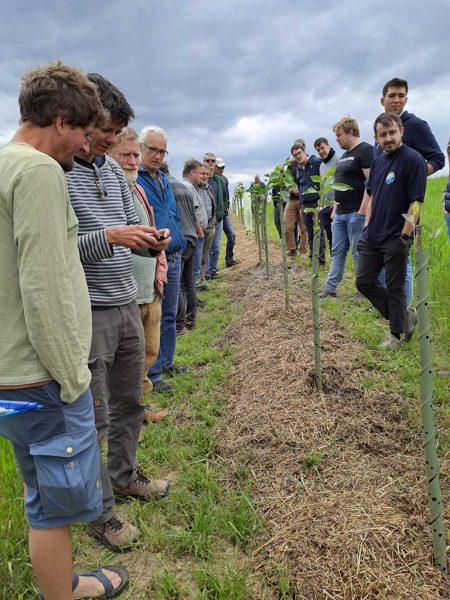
left=272, top=78, right=450, bottom=349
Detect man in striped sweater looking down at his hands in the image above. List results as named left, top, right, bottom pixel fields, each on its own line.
left=66, top=73, right=169, bottom=551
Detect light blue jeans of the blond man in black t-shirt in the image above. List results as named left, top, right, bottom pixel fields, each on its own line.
left=324, top=212, right=365, bottom=292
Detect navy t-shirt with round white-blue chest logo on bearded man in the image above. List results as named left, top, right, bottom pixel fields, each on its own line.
left=363, top=144, right=427, bottom=244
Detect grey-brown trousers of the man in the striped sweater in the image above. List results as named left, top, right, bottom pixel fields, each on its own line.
left=89, top=300, right=145, bottom=523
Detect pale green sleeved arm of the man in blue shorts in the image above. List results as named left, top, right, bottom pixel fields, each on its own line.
left=13, top=165, right=90, bottom=402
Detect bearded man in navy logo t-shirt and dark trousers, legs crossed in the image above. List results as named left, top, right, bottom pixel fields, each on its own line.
left=356, top=113, right=427, bottom=350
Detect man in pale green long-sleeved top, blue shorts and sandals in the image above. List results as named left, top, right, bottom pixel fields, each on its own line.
left=0, top=62, right=127, bottom=600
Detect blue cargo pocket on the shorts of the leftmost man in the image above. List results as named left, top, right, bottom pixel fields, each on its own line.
left=30, top=427, right=102, bottom=517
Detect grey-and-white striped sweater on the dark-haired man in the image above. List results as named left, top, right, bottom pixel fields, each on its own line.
left=66, top=157, right=139, bottom=306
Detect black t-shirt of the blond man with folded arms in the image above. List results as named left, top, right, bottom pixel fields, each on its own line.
left=334, top=142, right=373, bottom=214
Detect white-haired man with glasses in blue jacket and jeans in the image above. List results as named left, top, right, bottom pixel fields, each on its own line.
left=137, top=125, right=186, bottom=393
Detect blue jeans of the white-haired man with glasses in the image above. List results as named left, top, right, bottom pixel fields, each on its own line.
left=148, top=252, right=181, bottom=383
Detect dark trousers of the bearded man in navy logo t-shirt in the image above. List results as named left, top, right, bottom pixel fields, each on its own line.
left=356, top=237, right=408, bottom=335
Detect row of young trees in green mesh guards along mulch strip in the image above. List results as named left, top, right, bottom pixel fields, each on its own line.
left=233, top=168, right=448, bottom=573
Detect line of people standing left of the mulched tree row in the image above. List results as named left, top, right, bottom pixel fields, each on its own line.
left=0, top=62, right=238, bottom=600
